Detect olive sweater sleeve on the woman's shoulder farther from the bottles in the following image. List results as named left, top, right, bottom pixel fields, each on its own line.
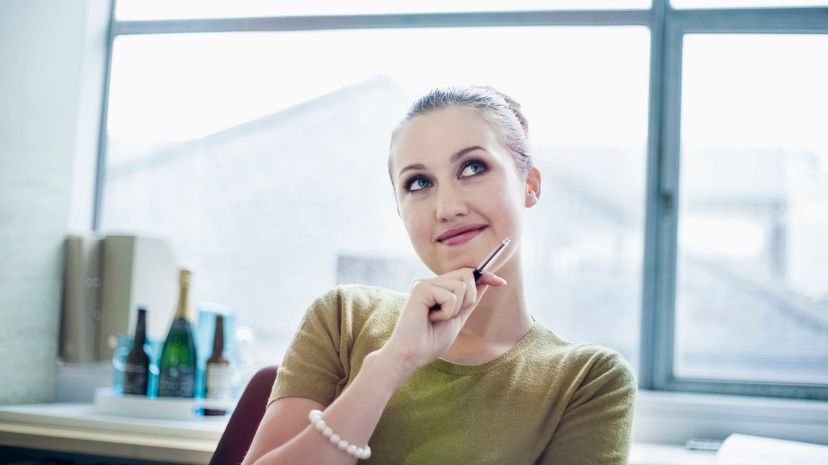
left=536, top=351, right=636, bottom=465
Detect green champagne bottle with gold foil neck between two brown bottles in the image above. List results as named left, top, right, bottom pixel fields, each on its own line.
left=158, top=268, right=196, bottom=397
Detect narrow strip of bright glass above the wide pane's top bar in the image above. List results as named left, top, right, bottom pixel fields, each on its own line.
left=115, top=0, right=650, bottom=20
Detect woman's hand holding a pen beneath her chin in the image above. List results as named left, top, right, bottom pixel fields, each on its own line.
left=378, top=268, right=506, bottom=379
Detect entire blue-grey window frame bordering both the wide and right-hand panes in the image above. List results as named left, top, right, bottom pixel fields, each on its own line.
left=92, top=0, right=828, bottom=400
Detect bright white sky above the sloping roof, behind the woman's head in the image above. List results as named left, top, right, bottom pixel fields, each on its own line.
left=109, top=27, right=649, bottom=146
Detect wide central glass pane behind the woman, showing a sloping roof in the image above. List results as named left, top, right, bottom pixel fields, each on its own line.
left=102, top=27, right=649, bottom=370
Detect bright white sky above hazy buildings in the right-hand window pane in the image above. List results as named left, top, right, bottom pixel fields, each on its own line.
left=682, top=34, right=828, bottom=158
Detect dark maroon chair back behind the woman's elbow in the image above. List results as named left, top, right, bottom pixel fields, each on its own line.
left=210, top=366, right=277, bottom=465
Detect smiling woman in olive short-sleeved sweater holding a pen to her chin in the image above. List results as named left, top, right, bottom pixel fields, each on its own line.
left=239, top=87, right=636, bottom=465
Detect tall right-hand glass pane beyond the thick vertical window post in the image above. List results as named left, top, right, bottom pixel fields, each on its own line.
left=675, top=35, right=828, bottom=383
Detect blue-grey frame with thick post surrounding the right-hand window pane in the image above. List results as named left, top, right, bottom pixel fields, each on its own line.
left=640, top=4, right=828, bottom=400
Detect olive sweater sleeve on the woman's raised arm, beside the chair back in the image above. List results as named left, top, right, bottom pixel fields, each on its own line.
left=267, top=288, right=345, bottom=407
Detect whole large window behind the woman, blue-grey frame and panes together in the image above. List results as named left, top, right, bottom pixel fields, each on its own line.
left=96, top=0, right=828, bottom=398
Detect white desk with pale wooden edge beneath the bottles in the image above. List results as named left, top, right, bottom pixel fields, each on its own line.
left=0, top=404, right=228, bottom=465
